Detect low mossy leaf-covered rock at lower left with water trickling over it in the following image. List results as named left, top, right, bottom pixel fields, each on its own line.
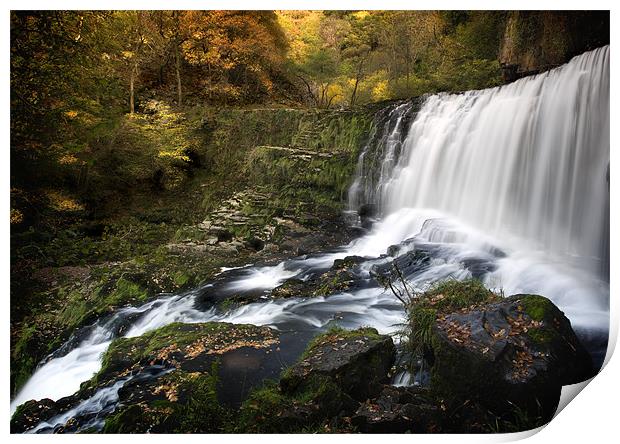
left=11, top=322, right=286, bottom=433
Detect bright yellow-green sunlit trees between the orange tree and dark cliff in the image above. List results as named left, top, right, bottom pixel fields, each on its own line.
left=278, top=11, right=505, bottom=107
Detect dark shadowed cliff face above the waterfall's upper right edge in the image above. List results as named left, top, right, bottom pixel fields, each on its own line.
left=499, top=11, right=609, bottom=81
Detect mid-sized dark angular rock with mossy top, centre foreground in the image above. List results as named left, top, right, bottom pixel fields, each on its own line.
left=280, top=328, right=394, bottom=401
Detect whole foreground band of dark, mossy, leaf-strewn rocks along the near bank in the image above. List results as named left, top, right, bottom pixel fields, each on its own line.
left=11, top=282, right=592, bottom=433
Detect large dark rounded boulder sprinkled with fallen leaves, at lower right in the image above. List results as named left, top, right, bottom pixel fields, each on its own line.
left=431, top=295, right=592, bottom=418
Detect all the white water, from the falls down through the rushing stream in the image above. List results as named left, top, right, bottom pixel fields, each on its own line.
left=11, top=47, right=609, bottom=431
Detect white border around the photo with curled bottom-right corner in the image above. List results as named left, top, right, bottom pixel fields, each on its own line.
left=0, top=0, right=620, bottom=444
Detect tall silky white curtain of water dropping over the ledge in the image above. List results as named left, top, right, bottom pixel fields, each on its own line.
left=349, top=46, right=609, bottom=279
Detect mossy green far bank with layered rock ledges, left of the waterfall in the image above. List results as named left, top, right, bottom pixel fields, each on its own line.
left=11, top=101, right=373, bottom=395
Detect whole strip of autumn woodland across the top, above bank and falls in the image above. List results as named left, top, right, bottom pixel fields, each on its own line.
left=10, top=11, right=609, bottom=227
